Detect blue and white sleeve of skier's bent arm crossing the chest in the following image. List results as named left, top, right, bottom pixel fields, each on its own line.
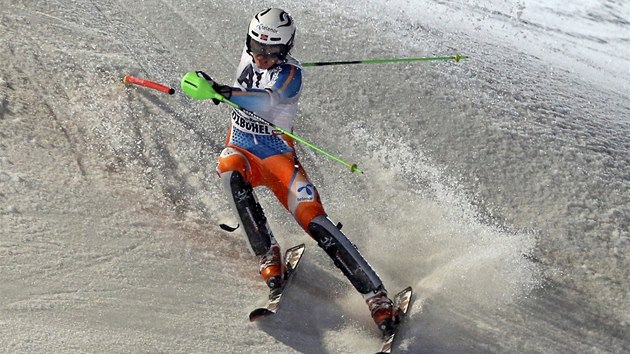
left=230, top=64, right=302, bottom=112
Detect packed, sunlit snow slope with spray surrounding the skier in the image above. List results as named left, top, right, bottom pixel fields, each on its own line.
left=0, top=0, right=630, bottom=353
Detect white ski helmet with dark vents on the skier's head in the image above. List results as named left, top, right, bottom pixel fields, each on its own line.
left=247, top=9, right=295, bottom=59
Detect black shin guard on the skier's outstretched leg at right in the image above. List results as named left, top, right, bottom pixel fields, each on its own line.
left=308, top=216, right=383, bottom=295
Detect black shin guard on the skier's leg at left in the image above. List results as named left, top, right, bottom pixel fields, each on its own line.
left=221, top=171, right=273, bottom=256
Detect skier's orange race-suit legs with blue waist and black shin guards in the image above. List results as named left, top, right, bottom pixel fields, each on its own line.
left=217, top=129, right=384, bottom=298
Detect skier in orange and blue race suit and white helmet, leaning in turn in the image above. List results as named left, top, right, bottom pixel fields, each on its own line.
left=197, top=8, right=397, bottom=333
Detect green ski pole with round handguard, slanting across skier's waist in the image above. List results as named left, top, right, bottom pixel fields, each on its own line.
left=182, top=71, right=363, bottom=173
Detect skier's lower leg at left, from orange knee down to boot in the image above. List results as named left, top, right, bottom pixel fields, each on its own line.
left=217, top=148, right=284, bottom=289
